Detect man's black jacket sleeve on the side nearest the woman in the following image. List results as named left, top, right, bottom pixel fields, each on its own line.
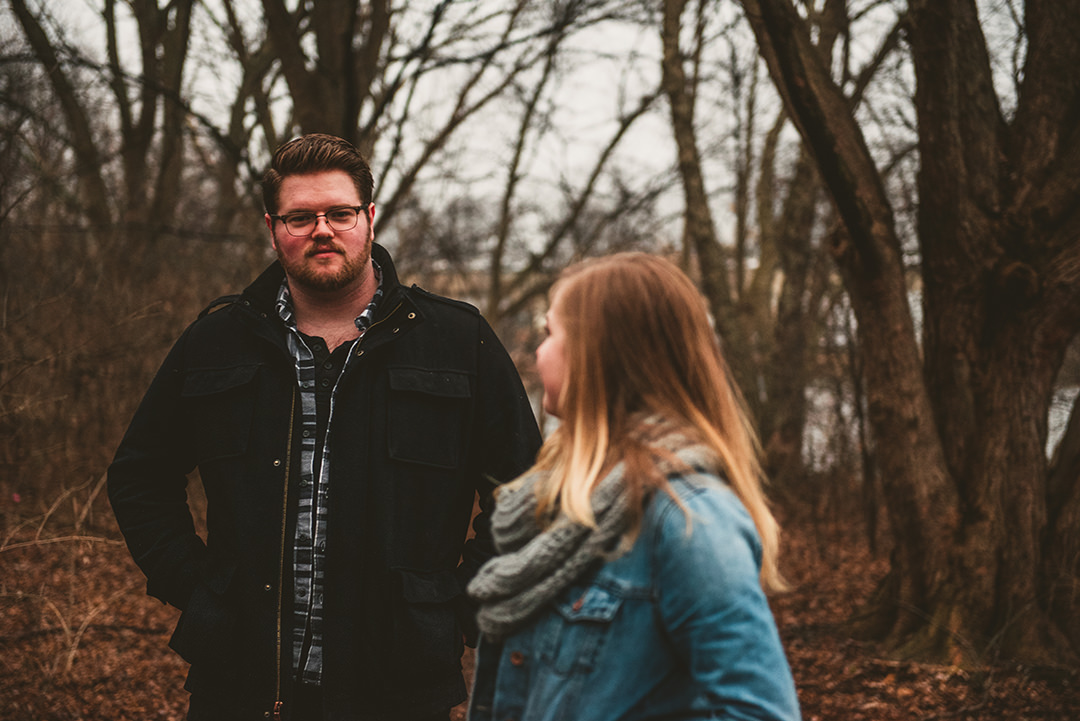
left=458, top=318, right=541, bottom=644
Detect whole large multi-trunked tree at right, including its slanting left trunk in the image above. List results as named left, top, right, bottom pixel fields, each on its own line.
left=743, top=0, right=1080, bottom=663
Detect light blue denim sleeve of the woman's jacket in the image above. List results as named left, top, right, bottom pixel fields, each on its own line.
left=654, top=486, right=800, bottom=721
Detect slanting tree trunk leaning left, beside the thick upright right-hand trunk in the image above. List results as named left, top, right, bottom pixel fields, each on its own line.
left=743, top=0, right=959, bottom=664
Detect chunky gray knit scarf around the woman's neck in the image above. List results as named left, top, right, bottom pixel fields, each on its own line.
left=469, top=418, right=718, bottom=640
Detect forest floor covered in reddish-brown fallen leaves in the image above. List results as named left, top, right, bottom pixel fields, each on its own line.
left=0, top=500, right=1080, bottom=721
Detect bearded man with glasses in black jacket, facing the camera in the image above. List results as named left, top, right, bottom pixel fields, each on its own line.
left=108, top=135, right=540, bottom=721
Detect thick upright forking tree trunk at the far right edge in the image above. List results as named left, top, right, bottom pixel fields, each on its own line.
left=909, top=1, right=1080, bottom=662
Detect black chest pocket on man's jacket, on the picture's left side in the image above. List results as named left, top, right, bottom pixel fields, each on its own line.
left=180, top=365, right=258, bottom=464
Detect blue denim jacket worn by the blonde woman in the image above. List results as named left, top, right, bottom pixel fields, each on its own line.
left=469, top=474, right=800, bottom=721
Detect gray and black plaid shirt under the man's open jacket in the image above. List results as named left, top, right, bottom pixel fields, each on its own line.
left=276, top=261, right=382, bottom=684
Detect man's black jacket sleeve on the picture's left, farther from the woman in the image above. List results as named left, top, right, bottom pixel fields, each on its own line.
left=108, top=332, right=205, bottom=609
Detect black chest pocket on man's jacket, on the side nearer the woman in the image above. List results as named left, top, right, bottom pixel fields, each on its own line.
left=387, top=368, right=472, bottom=468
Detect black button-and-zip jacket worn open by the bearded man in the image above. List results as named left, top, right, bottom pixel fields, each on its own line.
left=108, top=246, right=540, bottom=719
